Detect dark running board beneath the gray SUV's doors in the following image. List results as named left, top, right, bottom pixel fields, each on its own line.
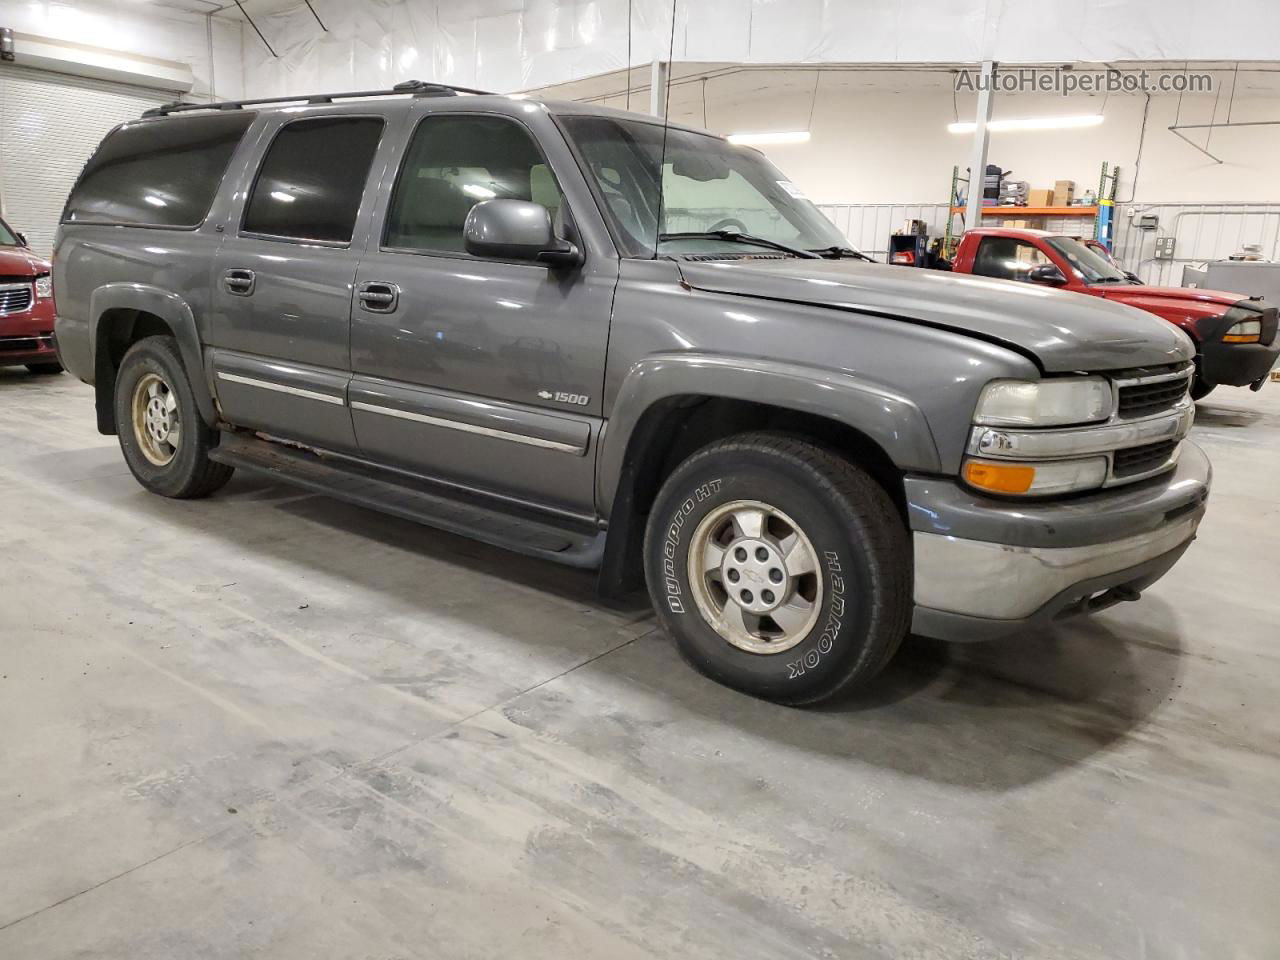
left=209, top=433, right=604, bottom=570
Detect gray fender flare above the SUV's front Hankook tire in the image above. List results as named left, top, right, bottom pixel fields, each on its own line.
left=596, top=353, right=941, bottom=516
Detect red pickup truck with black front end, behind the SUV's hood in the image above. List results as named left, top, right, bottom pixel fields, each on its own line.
left=951, top=227, right=1280, bottom=399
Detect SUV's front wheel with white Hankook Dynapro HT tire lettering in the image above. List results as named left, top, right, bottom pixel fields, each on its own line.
left=644, top=433, right=911, bottom=705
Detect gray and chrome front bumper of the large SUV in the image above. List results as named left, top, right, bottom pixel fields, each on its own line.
left=906, top=442, right=1212, bottom=640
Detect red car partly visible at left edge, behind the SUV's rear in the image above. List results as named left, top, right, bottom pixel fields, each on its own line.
left=0, top=220, right=63, bottom=374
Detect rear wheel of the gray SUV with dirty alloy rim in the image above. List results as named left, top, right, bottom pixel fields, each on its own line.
left=115, top=337, right=234, bottom=499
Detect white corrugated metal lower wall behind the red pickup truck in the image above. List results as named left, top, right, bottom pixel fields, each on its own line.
left=819, top=202, right=1280, bottom=287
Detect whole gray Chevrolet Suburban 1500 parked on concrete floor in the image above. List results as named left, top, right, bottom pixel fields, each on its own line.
left=54, top=82, right=1211, bottom=704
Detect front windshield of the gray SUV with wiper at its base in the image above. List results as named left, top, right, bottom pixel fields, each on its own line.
left=562, top=116, right=849, bottom=257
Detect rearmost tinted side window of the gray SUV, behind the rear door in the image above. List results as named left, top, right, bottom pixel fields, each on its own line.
left=63, top=111, right=253, bottom=227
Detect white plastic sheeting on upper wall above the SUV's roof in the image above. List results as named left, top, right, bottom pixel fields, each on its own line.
left=244, top=0, right=1280, bottom=95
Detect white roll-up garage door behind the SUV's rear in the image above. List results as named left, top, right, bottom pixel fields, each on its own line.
left=0, top=67, right=178, bottom=256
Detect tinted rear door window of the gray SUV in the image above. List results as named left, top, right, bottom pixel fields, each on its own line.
left=243, top=116, right=383, bottom=243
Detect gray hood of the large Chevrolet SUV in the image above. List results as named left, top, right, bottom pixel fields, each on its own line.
left=677, top=260, right=1194, bottom=372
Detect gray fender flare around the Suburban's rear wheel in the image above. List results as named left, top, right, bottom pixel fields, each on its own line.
left=90, top=283, right=218, bottom=434
